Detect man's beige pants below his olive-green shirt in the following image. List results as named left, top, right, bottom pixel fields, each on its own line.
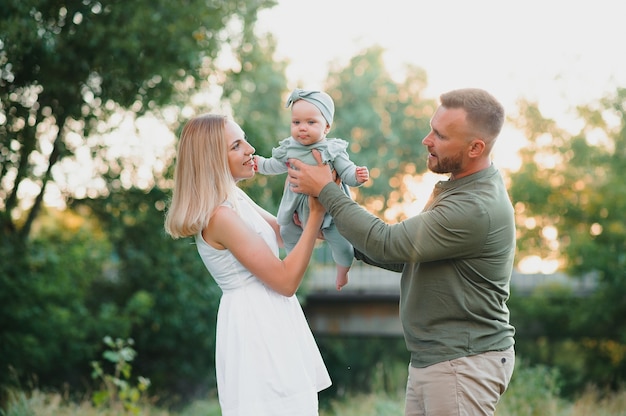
left=404, top=347, right=515, bottom=416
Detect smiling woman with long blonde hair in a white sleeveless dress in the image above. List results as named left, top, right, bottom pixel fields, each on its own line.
left=165, top=114, right=331, bottom=416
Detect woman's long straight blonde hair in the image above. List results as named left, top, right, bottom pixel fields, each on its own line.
left=165, top=114, right=236, bottom=238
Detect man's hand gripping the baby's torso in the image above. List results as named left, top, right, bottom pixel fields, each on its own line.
left=287, top=149, right=333, bottom=197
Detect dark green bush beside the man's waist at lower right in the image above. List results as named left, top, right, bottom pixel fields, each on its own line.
left=509, top=287, right=626, bottom=397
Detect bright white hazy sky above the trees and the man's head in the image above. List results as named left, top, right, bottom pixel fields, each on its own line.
left=259, top=0, right=626, bottom=133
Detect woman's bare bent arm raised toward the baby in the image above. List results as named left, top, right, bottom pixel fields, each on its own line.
left=202, top=197, right=324, bottom=296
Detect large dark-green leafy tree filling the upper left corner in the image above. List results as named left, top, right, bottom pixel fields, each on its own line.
left=0, top=0, right=274, bottom=241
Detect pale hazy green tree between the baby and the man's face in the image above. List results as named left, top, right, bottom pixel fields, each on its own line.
left=326, top=46, right=435, bottom=220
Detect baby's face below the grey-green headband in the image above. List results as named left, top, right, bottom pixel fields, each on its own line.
left=291, top=100, right=330, bottom=146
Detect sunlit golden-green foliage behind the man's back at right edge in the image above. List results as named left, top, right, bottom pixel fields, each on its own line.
left=510, top=90, right=626, bottom=282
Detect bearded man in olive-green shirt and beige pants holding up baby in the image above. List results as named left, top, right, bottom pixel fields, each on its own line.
left=289, top=89, right=515, bottom=416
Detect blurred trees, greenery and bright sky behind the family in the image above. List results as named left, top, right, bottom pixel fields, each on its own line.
left=0, top=0, right=626, bottom=415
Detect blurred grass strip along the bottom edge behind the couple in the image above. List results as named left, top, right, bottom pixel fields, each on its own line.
left=0, top=367, right=626, bottom=416
